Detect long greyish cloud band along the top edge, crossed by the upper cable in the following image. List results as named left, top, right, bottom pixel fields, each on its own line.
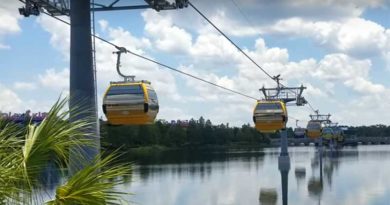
left=149, top=0, right=389, bottom=36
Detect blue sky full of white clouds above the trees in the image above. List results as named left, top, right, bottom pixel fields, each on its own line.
left=0, top=0, right=390, bottom=126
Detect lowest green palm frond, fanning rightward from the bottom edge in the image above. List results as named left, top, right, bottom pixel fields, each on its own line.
left=47, top=153, right=132, bottom=205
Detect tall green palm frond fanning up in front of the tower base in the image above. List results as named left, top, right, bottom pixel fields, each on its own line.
left=22, top=98, right=96, bottom=181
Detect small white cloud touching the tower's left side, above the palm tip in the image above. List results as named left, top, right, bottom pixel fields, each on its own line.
left=38, top=68, right=69, bottom=91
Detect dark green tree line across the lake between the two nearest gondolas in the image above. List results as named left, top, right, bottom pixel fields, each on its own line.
left=100, top=117, right=272, bottom=148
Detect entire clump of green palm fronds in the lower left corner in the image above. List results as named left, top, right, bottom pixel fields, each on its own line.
left=0, top=98, right=131, bottom=205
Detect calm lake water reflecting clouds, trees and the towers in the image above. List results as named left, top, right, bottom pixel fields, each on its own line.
left=120, top=145, right=390, bottom=205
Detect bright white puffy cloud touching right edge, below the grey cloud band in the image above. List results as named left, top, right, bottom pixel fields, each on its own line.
left=262, top=17, right=390, bottom=57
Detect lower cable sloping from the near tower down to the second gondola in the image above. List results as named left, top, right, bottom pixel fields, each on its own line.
left=31, top=7, right=258, bottom=100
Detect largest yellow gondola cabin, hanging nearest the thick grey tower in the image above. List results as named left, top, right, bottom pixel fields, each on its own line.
left=103, top=81, right=159, bottom=125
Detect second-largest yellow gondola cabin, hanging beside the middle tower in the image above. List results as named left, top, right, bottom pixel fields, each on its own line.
left=253, top=100, right=287, bottom=133
